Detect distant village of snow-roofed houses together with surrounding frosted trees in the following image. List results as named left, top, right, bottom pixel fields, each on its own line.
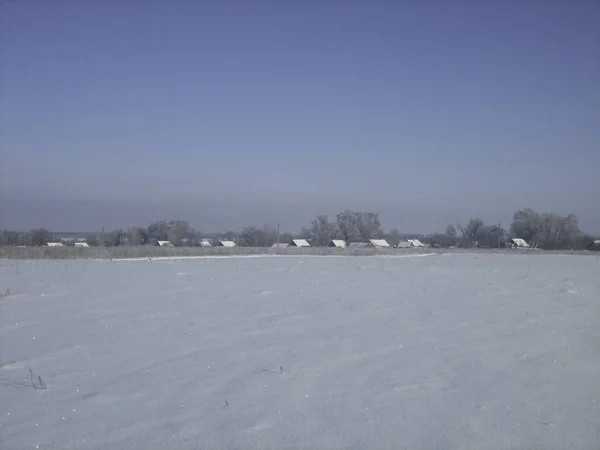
left=0, top=209, right=600, bottom=251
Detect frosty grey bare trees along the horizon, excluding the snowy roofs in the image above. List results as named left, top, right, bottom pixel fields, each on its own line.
left=0, top=208, right=593, bottom=250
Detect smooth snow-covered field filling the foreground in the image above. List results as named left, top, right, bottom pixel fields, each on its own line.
left=0, top=254, right=600, bottom=450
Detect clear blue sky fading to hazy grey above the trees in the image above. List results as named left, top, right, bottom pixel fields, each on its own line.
left=0, top=0, right=600, bottom=232
